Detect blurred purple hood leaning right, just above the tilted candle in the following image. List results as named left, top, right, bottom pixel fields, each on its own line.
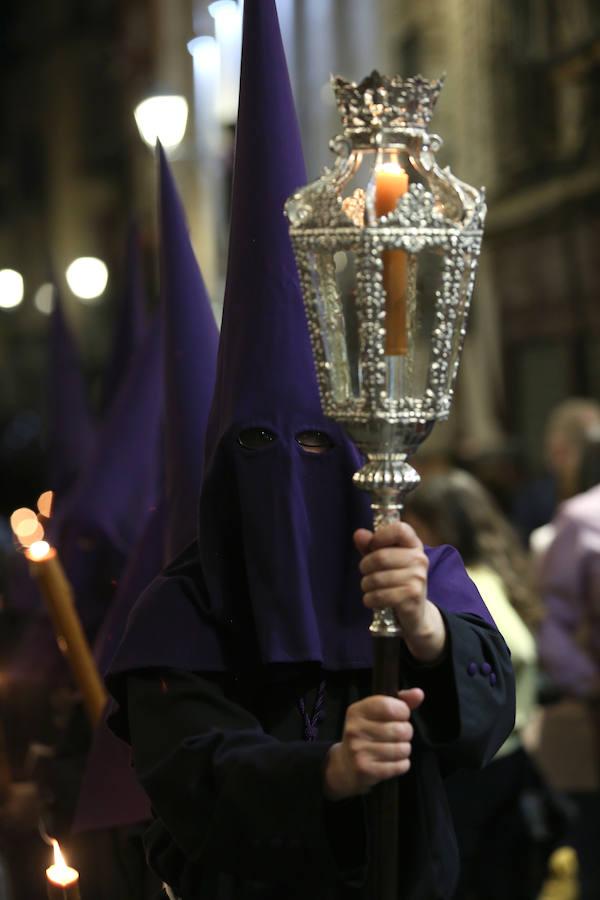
left=52, top=318, right=162, bottom=635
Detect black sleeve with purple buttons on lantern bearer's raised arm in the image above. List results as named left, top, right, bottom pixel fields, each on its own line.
left=402, top=612, right=515, bottom=772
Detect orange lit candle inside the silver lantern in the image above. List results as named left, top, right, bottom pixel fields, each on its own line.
left=375, top=158, right=408, bottom=356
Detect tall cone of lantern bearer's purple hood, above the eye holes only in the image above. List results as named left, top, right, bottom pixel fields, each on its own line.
left=207, top=0, right=320, bottom=456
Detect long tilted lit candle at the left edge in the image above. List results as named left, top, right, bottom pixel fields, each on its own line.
left=25, top=541, right=108, bottom=726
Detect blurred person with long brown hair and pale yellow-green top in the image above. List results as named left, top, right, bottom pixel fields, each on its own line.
left=405, top=470, right=563, bottom=900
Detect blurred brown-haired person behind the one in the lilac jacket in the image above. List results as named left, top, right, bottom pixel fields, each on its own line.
left=513, top=397, right=600, bottom=554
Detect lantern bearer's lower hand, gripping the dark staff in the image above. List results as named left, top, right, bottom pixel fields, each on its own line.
left=325, top=688, right=425, bottom=800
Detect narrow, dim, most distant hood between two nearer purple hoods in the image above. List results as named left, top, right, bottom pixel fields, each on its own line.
left=104, top=222, right=148, bottom=408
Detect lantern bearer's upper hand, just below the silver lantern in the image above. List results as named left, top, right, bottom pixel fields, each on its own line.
left=354, top=522, right=446, bottom=662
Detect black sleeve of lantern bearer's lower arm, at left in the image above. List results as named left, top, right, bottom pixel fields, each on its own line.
left=128, top=671, right=366, bottom=882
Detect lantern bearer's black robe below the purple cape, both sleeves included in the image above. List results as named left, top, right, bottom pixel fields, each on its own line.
left=118, top=613, right=514, bottom=900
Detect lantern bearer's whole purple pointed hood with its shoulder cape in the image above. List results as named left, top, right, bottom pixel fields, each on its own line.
left=110, top=0, right=496, bottom=696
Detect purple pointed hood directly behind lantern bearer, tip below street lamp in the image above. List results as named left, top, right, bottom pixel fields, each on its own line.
left=74, top=148, right=218, bottom=830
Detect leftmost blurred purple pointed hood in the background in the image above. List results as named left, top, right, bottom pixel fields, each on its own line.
left=47, top=291, right=94, bottom=501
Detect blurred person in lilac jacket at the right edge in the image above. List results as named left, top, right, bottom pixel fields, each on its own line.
left=539, top=427, right=600, bottom=900
